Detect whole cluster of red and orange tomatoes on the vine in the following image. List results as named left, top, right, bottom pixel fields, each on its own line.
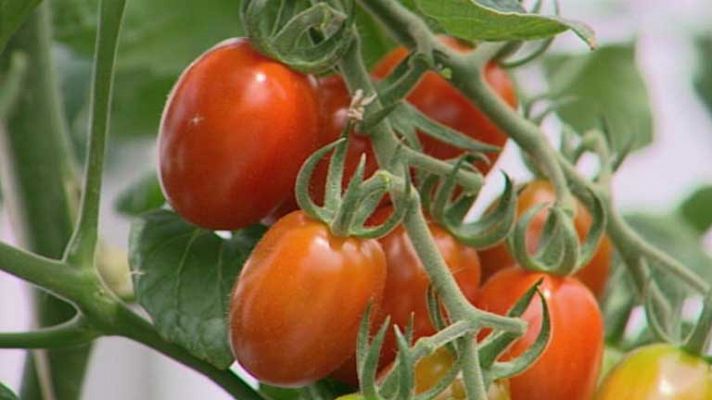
left=159, top=38, right=688, bottom=400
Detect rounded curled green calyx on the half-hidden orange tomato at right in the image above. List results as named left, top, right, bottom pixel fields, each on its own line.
left=509, top=204, right=580, bottom=275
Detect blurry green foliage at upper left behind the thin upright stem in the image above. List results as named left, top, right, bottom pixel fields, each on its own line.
left=53, top=0, right=242, bottom=137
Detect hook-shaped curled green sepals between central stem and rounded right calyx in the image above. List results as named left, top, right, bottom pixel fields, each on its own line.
left=438, top=173, right=517, bottom=249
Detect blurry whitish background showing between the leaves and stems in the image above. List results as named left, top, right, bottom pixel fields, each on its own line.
left=0, top=0, right=712, bottom=400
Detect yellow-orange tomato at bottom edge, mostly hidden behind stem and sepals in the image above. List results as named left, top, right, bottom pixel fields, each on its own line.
left=415, top=347, right=510, bottom=400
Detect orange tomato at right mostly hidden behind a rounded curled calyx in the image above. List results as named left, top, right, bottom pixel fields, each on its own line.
left=480, top=180, right=613, bottom=298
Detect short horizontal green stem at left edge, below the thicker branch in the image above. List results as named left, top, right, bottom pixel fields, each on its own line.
left=0, top=315, right=98, bottom=349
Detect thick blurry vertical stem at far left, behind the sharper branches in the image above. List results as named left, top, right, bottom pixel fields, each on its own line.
left=0, top=2, right=90, bottom=400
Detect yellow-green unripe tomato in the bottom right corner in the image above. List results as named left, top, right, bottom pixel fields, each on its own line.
left=595, top=344, right=712, bottom=400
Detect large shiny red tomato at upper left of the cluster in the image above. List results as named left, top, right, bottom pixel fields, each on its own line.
left=158, top=38, right=320, bottom=229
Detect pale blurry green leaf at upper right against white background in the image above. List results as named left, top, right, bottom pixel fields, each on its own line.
left=544, top=43, right=653, bottom=151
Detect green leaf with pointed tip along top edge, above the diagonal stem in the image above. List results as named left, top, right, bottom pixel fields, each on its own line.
left=415, top=0, right=596, bottom=48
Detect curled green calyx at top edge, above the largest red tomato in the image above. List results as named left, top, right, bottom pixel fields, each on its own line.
left=241, top=0, right=355, bottom=73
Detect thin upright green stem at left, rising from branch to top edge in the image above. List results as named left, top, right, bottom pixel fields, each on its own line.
left=66, top=0, right=126, bottom=268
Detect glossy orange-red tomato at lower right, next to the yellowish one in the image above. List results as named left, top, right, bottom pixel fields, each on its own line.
left=476, top=267, right=603, bottom=400
